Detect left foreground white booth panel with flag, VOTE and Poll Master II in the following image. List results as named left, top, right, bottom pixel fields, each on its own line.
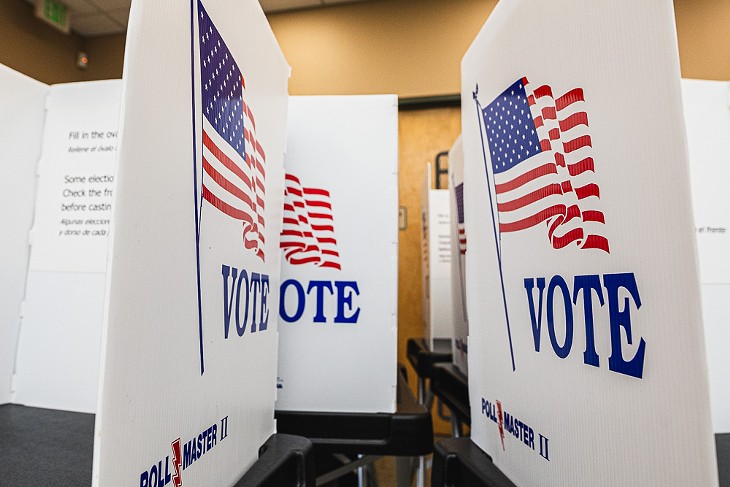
left=93, top=0, right=289, bottom=487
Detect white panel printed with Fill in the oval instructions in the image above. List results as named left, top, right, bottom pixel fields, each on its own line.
left=13, top=80, right=121, bottom=412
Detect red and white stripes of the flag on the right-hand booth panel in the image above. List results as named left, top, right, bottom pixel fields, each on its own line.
left=495, top=78, right=609, bottom=252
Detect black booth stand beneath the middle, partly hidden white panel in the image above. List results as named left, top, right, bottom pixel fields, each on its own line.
left=276, top=370, right=433, bottom=485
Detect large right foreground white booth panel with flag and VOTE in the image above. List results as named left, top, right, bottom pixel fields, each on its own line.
left=462, top=0, right=718, bottom=486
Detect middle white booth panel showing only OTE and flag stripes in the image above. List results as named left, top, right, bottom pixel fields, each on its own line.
left=276, top=95, right=398, bottom=413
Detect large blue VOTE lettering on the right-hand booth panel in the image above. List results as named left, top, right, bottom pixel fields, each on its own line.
left=524, top=273, right=646, bottom=379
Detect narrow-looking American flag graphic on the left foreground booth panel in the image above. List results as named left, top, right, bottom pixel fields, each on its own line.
left=198, top=2, right=266, bottom=260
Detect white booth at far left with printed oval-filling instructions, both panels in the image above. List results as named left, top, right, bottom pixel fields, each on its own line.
left=0, top=67, right=121, bottom=413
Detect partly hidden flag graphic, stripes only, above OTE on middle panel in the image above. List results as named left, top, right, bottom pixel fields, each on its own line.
left=281, top=174, right=341, bottom=270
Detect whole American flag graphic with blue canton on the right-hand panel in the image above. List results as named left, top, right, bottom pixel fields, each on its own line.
left=482, top=78, right=609, bottom=252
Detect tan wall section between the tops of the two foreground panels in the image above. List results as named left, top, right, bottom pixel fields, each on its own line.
left=269, top=0, right=497, bottom=96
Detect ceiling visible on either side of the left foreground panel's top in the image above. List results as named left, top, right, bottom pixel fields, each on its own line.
left=26, top=0, right=362, bottom=37
